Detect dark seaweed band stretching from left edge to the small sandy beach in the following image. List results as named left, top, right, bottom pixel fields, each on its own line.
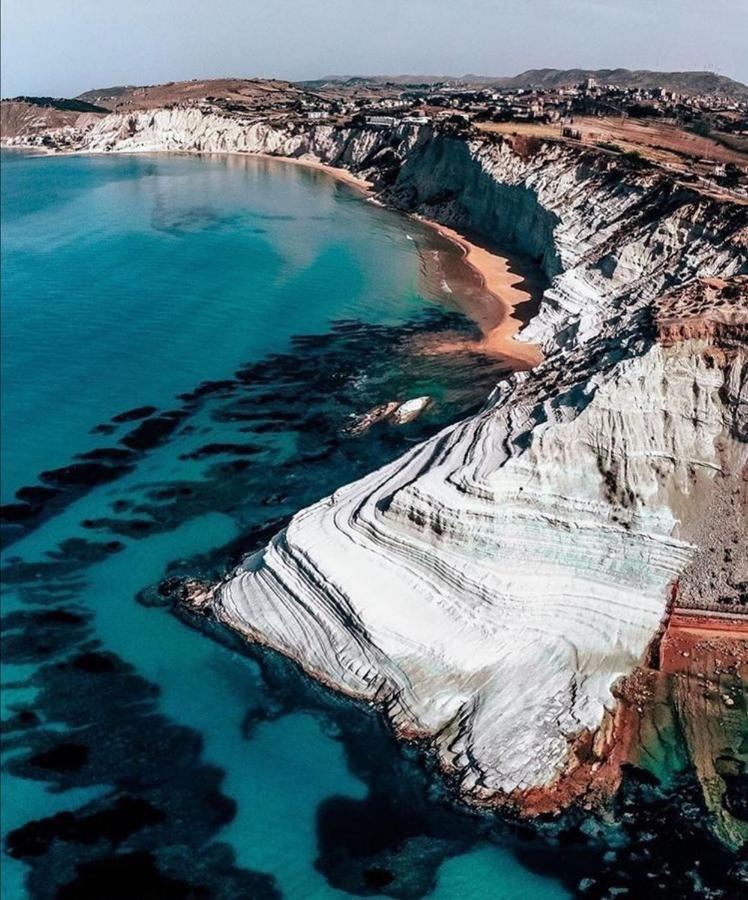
left=0, top=310, right=496, bottom=544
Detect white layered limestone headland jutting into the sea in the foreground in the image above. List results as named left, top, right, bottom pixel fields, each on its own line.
left=211, top=345, right=744, bottom=799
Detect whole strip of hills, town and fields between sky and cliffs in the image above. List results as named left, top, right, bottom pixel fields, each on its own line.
left=2, top=70, right=748, bottom=197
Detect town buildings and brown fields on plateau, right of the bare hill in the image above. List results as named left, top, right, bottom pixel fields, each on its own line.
left=287, top=78, right=748, bottom=193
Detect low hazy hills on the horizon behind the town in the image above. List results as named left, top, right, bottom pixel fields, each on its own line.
left=300, top=69, right=748, bottom=99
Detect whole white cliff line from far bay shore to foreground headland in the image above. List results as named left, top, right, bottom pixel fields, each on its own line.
left=7, top=102, right=748, bottom=842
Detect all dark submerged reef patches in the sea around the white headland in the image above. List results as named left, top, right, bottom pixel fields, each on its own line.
left=2, top=312, right=748, bottom=900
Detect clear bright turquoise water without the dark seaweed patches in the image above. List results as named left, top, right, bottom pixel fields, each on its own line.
left=2, top=154, right=567, bottom=900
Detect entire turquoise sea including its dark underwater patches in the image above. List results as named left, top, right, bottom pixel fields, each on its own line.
left=2, top=153, right=732, bottom=900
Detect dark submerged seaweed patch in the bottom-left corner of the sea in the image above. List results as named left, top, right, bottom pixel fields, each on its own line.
left=3, top=596, right=280, bottom=900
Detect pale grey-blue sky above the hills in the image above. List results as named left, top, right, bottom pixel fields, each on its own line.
left=0, top=0, right=748, bottom=97
